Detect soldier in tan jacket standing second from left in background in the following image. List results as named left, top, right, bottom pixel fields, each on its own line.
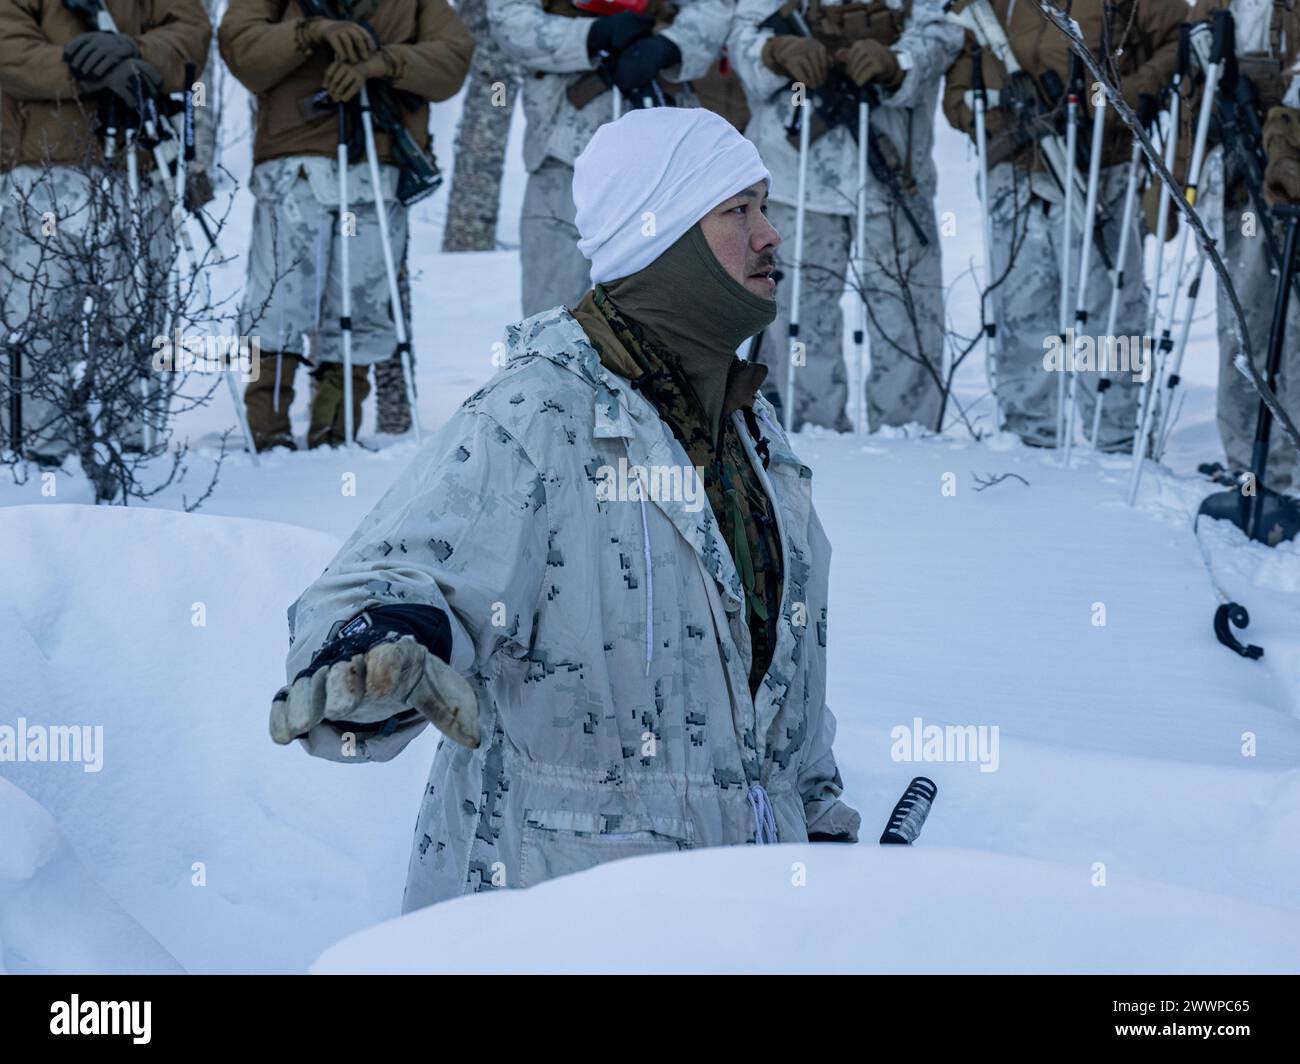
left=218, top=0, right=473, bottom=450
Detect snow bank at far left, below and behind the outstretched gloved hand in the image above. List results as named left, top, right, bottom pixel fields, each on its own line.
left=0, top=505, right=433, bottom=972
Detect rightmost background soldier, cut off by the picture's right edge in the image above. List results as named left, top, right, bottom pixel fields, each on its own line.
left=1190, top=0, right=1300, bottom=492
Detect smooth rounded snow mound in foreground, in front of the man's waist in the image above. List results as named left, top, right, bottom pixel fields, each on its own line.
left=311, top=843, right=1300, bottom=976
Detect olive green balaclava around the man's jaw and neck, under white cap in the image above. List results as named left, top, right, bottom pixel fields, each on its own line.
left=605, top=222, right=776, bottom=440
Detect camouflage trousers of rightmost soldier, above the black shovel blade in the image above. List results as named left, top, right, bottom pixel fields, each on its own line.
left=1206, top=191, right=1300, bottom=492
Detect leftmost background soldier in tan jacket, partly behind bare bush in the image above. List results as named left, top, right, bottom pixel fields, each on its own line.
left=0, top=0, right=212, bottom=467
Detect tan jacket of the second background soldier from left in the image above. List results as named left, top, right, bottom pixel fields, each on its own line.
left=217, top=0, right=475, bottom=163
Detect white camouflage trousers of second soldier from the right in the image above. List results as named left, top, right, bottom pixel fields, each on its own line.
left=989, top=163, right=1147, bottom=450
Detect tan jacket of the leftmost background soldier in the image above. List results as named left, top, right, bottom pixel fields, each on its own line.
left=0, top=0, right=212, bottom=173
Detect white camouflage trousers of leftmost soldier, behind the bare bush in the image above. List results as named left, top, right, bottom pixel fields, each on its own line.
left=0, top=166, right=170, bottom=460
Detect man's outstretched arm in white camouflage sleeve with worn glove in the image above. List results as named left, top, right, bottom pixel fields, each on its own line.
left=272, top=408, right=549, bottom=760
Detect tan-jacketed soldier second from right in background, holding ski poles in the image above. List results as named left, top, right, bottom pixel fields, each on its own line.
left=944, top=0, right=1187, bottom=451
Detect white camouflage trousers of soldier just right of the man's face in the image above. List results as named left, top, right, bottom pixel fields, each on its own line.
left=758, top=196, right=944, bottom=432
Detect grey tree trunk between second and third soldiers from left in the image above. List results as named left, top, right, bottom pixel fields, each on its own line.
left=442, top=0, right=517, bottom=251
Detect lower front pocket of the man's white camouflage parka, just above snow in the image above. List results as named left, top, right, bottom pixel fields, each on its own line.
left=519, top=809, right=696, bottom=887
